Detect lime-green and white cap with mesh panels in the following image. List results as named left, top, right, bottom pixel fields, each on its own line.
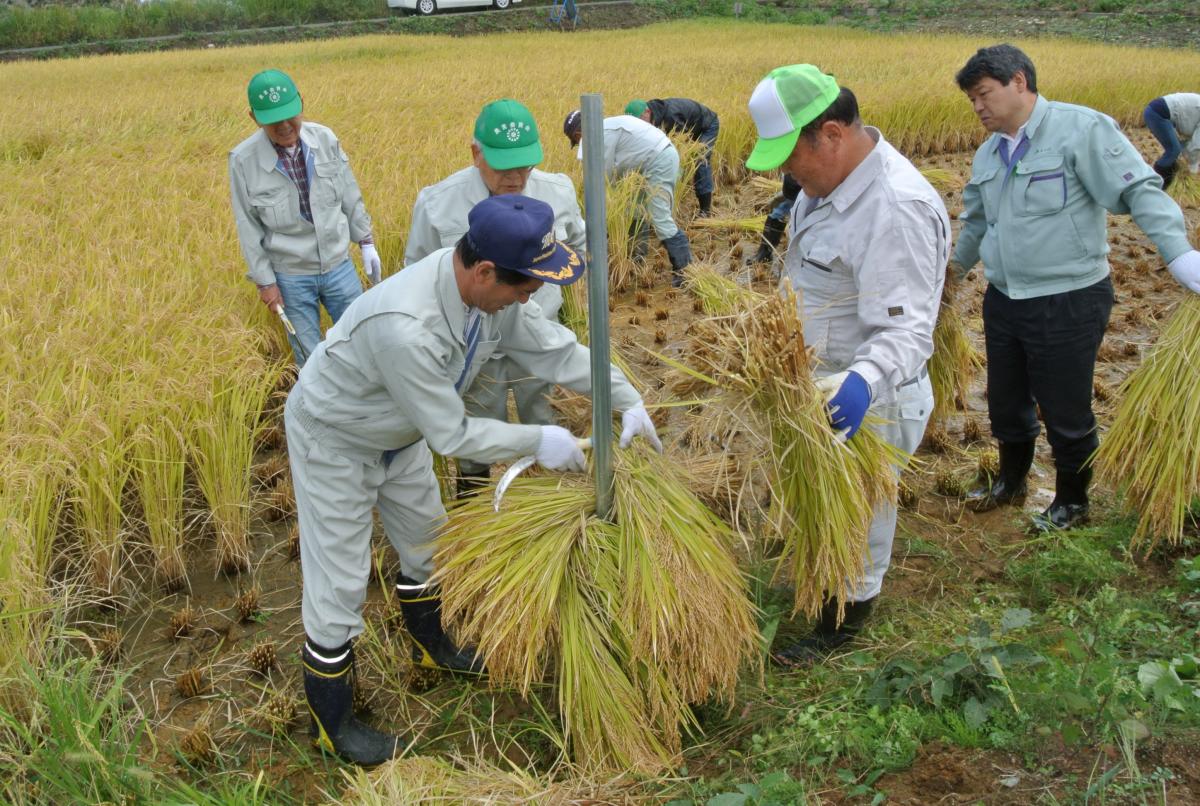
left=746, top=65, right=841, bottom=170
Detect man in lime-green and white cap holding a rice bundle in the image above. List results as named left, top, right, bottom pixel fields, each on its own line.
left=746, top=65, right=950, bottom=664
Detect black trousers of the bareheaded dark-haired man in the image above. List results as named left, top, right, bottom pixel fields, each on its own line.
left=983, top=277, right=1112, bottom=473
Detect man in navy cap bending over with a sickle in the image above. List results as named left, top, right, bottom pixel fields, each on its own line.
left=284, top=196, right=661, bottom=764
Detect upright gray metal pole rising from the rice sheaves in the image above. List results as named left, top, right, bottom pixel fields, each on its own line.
left=580, top=92, right=612, bottom=521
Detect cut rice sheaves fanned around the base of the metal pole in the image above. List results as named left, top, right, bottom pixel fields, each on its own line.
left=437, top=447, right=758, bottom=772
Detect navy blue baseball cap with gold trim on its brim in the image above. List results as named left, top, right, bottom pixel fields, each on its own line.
left=467, top=193, right=583, bottom=285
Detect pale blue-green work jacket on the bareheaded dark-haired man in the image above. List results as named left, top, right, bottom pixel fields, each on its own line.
left=954, top=96, right=1192, bottom=300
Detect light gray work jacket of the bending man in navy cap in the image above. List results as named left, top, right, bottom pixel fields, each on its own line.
left=288, top=248, right=641, bottom=464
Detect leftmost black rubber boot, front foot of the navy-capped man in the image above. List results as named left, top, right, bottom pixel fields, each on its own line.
left=301, top=640, right=404, bottom=766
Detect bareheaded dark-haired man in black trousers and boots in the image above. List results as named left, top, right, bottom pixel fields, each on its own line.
left=952, top=44, right=1200, bottom=530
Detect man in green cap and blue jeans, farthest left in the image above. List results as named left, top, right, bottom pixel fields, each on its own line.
left=229, top=70, right=383, bottom=365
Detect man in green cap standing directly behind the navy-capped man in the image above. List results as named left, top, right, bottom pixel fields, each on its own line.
left=404, top=98, right=587, bottom=497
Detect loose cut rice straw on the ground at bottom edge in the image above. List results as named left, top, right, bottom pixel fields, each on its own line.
left=332, top=756, right=642, bottom=806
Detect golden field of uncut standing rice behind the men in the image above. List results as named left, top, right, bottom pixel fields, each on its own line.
left=0, top=17, right=1200, bottom=782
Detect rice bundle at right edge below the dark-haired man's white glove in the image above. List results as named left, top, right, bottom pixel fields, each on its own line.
left=1093, top=295, right=1200, bottom=552
